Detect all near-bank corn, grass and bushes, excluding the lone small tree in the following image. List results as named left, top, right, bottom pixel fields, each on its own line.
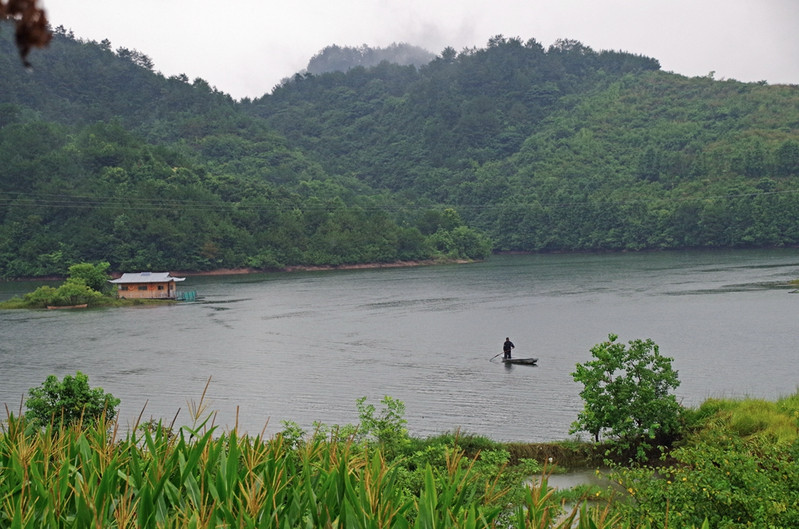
left=6, top=360, right=799, bottom=529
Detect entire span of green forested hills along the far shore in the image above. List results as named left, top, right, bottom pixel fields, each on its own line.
left=0, top=27, right=799, bottom=277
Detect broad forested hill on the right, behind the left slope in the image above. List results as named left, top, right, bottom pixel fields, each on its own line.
left=248, top=36, right=799, bottom=251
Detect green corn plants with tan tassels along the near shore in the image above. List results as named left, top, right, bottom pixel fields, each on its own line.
left=0, top=416, right=708, bottom=529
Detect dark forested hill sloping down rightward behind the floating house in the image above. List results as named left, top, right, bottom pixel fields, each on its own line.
left=0, top=27, right=491, bottom=278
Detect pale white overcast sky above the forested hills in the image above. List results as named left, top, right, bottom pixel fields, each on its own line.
left=39, top=0, right=799, bottom=99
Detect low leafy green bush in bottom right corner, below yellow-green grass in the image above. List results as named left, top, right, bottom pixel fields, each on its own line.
left=617, top=432, right=799, bottom=529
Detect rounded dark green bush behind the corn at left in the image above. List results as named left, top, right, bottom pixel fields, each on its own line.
left=25, top=371, right=121, bottom=428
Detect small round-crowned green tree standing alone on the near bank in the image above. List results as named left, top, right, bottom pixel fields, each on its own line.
left=572, top=334, right=681, bottom=455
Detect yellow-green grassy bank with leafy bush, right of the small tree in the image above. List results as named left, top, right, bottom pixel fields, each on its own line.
left=614, top=393, right=799, bottom=529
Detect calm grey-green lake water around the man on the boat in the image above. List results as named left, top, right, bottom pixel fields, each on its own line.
left=0, top=250, right=799, bottom=441
